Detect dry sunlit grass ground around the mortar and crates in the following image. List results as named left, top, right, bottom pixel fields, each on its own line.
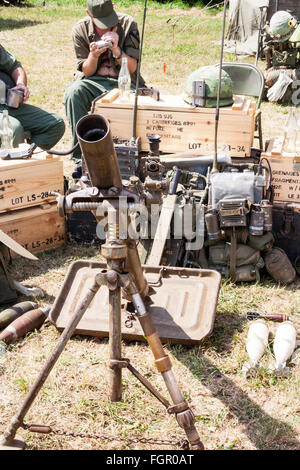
left=0, top=1, right=300, bottom=450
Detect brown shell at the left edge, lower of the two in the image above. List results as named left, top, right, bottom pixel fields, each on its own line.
left=0, top=307, right=50, bottom=343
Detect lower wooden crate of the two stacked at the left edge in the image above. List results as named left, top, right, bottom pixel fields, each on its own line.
left=0, top=202, right=66, bottom=256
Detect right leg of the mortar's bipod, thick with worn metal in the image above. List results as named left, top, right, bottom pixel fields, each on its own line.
left=121, top=274, right=204, bottom=450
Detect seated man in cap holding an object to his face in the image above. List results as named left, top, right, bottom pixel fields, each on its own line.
left=64, top=0, right=145, bottom=163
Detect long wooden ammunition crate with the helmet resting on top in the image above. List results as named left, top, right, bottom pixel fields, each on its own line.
left=95, top=95, right=256, bottom=157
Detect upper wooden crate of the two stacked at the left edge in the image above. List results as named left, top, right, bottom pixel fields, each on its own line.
left=0, top=149, right=64, bottom=213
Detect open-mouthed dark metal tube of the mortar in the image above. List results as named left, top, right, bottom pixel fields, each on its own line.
left=76, top=114, right=122, bottom=189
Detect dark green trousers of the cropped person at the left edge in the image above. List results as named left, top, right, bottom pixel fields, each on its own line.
left=0, top=103, right=65, bottom=150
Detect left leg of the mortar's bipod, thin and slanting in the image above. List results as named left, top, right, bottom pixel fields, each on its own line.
left=0, top=273, right=105, bottom=449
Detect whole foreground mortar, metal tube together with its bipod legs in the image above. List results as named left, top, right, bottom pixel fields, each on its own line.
left=2, top=115, right=220, bottom=450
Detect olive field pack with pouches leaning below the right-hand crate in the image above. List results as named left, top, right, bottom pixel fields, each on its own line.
left=205, top=164, right=294, bottom=283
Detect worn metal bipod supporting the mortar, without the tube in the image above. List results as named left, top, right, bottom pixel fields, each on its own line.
left=1, top=233, right=203, bottom=450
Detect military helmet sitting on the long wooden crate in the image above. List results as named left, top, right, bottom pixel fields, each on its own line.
left=184, top=66, right=233, bottom=108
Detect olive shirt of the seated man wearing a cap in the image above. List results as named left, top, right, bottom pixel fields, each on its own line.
left=72, top=13, right=145, bottom=87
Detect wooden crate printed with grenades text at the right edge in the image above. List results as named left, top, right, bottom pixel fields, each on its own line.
left=262, top=139, right=300, bottom=203
